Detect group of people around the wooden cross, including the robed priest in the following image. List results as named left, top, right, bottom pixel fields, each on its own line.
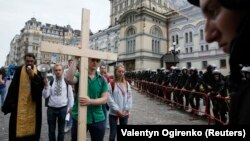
left=0, top=53, right=132, bottom=141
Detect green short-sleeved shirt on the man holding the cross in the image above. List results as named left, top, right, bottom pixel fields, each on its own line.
left=72, top=72, right=108, bottom=124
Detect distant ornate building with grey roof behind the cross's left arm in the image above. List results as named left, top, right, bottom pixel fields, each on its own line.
left=6, top=18, right=80, bottom=65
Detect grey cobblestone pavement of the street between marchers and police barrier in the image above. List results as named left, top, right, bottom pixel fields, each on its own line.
left=0, top=87, right=207, bottom=141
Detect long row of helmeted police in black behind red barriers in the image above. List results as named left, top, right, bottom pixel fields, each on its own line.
left=126, top=65, right=229, bottom=124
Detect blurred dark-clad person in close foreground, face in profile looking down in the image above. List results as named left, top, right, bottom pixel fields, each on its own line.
left=188, top=0, right=250, bottom=124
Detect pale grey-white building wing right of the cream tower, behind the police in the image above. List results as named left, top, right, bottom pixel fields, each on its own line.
left=168, top=1, right=229, bottom=75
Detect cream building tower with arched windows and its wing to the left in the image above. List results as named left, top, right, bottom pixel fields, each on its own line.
left=90, top=0, right=172, bottom=71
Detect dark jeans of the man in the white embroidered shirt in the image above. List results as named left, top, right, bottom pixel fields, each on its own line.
left=47, top=106, right=68, bottom=141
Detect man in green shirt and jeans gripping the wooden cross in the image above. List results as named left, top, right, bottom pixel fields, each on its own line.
left=67, top=58, right=109, bottom=141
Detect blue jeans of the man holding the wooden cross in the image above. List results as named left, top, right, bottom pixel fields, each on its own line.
left=71, top=118, right=105, bottom=141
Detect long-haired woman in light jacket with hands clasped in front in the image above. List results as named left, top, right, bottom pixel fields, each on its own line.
left=108, top=64, right=132, bottom=141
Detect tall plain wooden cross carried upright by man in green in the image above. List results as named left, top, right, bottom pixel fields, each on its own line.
left=41, top=8, right=117, bottom=141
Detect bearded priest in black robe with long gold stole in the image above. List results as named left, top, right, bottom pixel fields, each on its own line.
left=2, top=53, right=44, bottom=141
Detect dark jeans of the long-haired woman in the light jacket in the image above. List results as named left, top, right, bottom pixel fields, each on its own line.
left=109, top=115, right=128, bottom=141
